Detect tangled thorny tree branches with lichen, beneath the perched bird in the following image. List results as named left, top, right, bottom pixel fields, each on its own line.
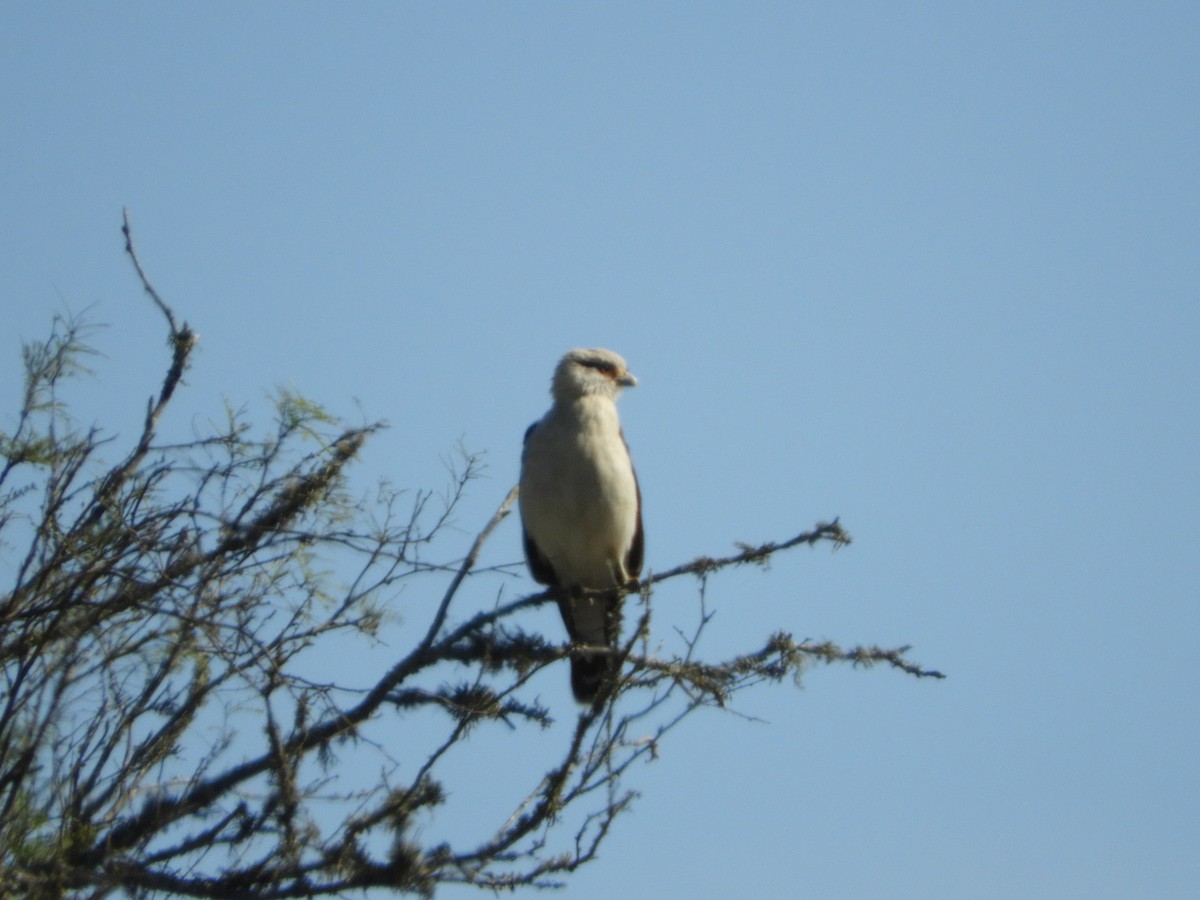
left=0, top=212, right=942, bottom=898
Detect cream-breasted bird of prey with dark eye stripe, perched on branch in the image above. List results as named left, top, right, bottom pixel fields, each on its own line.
left=517, top=348, right=646, bottom=703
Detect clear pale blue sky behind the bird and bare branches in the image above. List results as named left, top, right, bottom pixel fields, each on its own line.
left=0, top=2, right=1200, bottom=900
